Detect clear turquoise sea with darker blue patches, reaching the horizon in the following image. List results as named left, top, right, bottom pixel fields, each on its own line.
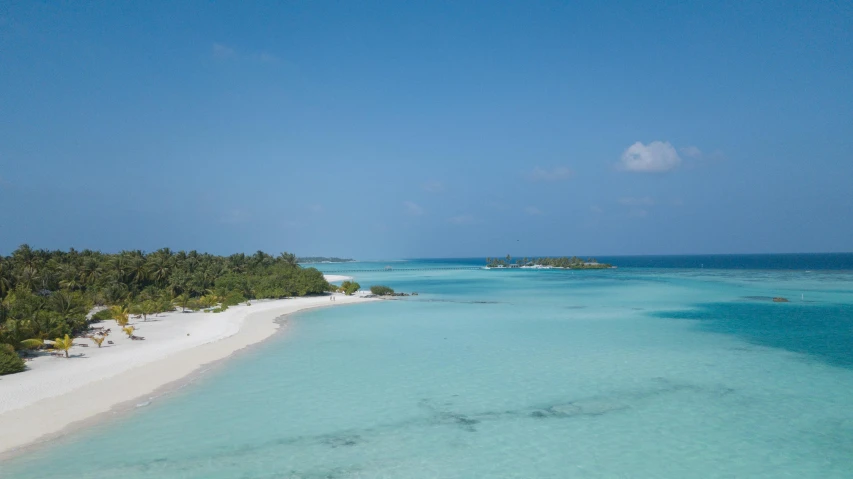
left=0, top=254, right=853, bottom=479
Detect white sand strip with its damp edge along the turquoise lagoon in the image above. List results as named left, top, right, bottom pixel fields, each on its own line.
left=0, top=294, right=375, bottom=461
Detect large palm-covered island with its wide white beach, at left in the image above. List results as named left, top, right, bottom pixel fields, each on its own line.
left=0, top=245, right=378, bottom=457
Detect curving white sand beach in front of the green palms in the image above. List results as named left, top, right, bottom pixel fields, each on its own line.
left=0, top=290, right=370, bottom=458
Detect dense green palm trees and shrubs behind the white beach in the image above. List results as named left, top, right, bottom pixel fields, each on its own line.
left=0, top=245, right=330, bottom=350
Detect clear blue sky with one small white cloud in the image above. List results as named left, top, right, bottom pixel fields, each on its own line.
left=0, top=0, right=853, bottom=259
